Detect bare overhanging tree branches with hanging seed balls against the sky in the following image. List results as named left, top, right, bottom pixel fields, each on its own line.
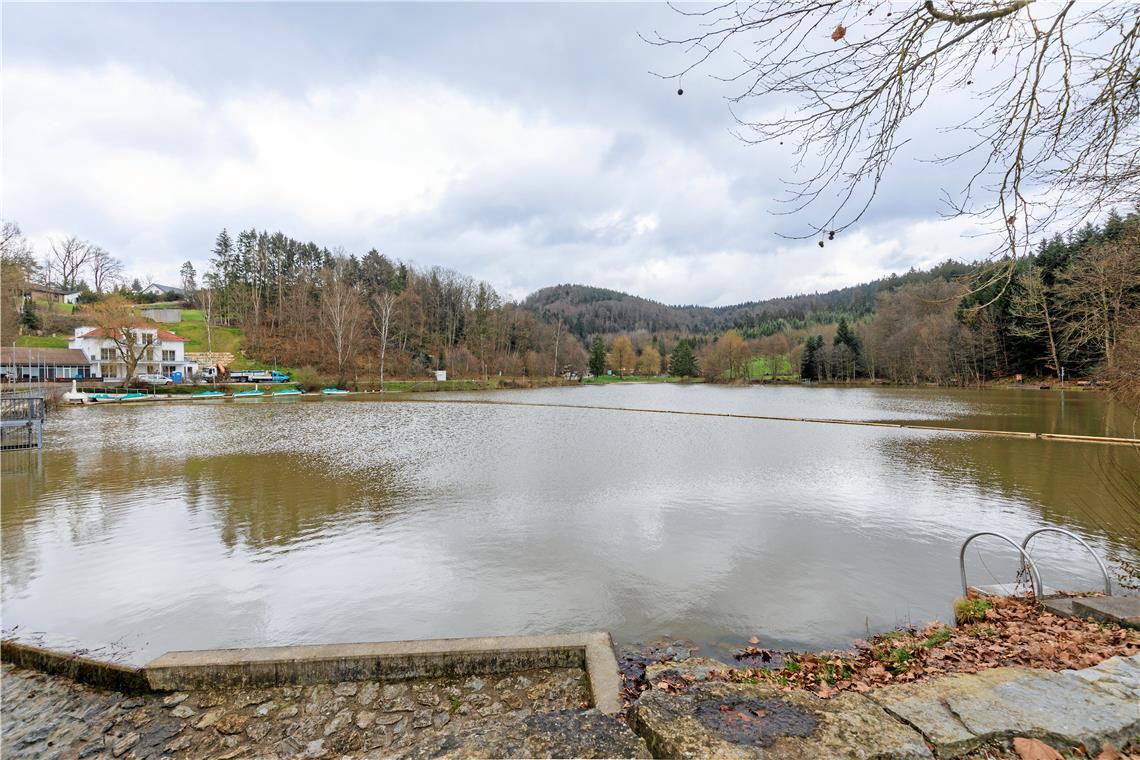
left=646, top=0, right=1140, bottom=254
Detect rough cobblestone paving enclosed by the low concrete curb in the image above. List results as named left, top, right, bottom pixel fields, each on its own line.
left=0, top=663, right=589, bottom=760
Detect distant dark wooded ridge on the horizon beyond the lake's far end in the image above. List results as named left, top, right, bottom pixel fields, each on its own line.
left=522, top=261, right=977, bottom=338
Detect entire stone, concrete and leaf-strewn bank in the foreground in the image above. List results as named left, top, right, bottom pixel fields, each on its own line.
left=2, top=597, right=1140, bottom=760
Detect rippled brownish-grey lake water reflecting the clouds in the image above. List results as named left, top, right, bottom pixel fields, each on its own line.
left=2, top=385, right=1140, bottom=662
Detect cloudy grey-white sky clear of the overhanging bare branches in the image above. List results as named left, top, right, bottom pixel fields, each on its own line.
left=0, top=2, right=991, bottom=305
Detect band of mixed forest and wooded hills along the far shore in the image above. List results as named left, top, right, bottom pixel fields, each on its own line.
left=2, top=213, right=1140, bottom=384
